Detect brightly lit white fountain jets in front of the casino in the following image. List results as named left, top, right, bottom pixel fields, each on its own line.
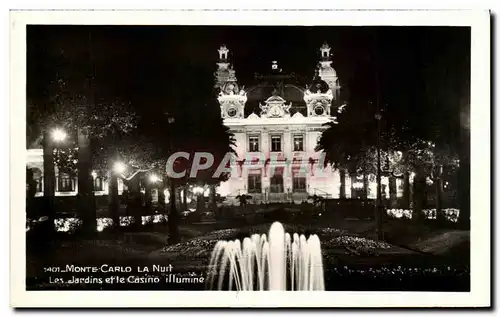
left=207, top=222, right=325, bottom=291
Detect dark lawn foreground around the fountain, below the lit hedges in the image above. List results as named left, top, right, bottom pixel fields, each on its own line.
left=26, top=216, right=470, bottom=292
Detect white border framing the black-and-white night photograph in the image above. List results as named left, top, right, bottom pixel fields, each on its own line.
left=10, top=10, right=491, bottom=307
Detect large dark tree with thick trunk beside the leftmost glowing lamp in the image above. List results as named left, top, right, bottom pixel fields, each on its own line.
left=28, top=39, right=135, bottom=233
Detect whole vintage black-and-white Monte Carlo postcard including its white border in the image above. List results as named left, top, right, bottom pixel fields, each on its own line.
left=10, top=10, right=491, bottom=308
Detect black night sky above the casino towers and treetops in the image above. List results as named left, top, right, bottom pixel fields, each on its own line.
left=27, top=26, right=470, bottom=146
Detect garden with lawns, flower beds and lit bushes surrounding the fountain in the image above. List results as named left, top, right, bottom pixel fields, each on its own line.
left=26, top=204, right=470, bottom=291
